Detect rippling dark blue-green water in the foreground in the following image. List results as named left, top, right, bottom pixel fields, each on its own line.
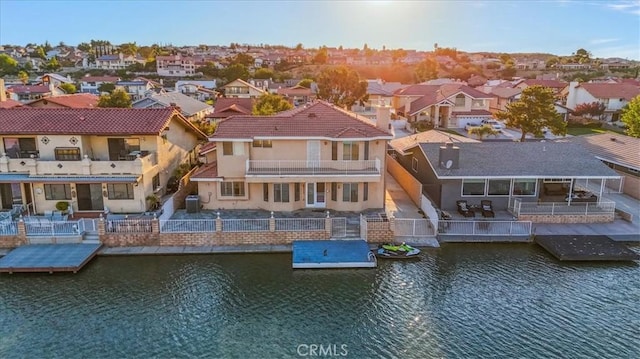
left=0, top=244, right=640, bottom=358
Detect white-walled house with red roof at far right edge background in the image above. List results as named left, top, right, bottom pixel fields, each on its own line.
left=567, top=82, right=640, bottom=121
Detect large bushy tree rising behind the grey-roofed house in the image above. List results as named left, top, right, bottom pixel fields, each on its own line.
left=496, top=86, right=567, bottom=142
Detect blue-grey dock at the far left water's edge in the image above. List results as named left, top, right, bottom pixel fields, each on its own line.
left=0, top=243, right=102, bottom=273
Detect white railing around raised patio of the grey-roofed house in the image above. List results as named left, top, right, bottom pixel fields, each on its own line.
left=513, top=200, right=616, bottom=216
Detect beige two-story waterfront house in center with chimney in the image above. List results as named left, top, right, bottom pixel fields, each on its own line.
left=191, top=101, right=393, bottom=211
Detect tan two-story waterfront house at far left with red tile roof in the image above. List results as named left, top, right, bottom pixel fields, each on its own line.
left=0, top=107, right=206, bottom=213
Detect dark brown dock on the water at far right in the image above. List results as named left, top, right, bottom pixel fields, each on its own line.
left=535, top=235, right=640, bottom=261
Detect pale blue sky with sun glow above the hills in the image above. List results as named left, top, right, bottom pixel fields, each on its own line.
left=0, top=0, right=640, bottom=60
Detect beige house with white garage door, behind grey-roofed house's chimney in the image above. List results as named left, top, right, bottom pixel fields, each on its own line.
left=393, top=83, right=494, bottom=128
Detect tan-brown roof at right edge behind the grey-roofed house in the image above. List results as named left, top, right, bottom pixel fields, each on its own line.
left=569, top=132, right=640, bottom=171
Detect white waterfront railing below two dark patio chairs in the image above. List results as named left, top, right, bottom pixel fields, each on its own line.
left=438, top=220, right=532, bottom=236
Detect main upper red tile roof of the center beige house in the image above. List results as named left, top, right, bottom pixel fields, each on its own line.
left=211, top=101, right=392, bottom=140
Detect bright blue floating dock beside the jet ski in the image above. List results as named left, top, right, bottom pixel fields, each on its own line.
left=292, top=239, right=377, bottom=269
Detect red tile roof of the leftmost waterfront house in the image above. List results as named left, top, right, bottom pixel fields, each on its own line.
left=0, top=106, right=192, bottom=135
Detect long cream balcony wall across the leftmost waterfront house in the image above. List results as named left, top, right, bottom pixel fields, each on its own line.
left=0, top=152, right=158, bottom=176
